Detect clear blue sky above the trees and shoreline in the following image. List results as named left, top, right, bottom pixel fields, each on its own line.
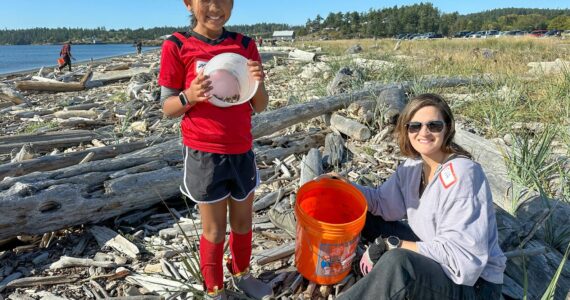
left=0, top=0, right=570, bottom=29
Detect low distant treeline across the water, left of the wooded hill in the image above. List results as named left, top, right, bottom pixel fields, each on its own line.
left=0, top=23, right=300, bottom=45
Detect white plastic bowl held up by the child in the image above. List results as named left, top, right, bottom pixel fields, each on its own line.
left=204, top=53, right=259, bottom=107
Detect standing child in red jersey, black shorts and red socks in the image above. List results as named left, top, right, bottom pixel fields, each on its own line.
left=159, top=0, right=272, bottom=299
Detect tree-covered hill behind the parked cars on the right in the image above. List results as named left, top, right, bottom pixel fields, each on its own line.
left=298, top=3, right=570, bottom=38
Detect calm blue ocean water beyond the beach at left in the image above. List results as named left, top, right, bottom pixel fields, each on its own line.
left=0, top=44, right=156, bottom=74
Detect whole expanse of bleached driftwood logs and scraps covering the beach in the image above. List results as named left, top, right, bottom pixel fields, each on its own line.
left=0, top=49, right=570, bottom=299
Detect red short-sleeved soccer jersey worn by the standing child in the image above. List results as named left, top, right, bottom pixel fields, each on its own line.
left=158, top=29, right=261, bottom=154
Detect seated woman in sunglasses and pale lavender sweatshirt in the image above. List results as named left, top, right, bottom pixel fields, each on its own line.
left=333, top=94, right=506, bottom=300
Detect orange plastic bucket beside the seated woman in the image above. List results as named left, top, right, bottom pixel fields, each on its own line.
left=295, top=178, right=368, bottom=285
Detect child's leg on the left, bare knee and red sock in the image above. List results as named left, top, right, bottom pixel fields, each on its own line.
left=198, top=199, right=228, bottom=292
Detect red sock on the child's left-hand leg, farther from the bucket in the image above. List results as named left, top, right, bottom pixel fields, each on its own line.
left=200, top=236, right=224, bottom=292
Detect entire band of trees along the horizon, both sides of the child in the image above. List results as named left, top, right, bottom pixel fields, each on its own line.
left=0, top=3, right=570, bottom=45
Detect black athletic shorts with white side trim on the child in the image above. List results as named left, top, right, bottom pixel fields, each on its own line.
left=180, top=146, right=259, bottom=203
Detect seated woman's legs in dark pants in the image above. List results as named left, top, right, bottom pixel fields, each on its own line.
left=338, top=213, right=501, bottom=300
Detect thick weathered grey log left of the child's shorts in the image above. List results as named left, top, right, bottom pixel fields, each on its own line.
left=0, top=141, right=182, bottom=239
